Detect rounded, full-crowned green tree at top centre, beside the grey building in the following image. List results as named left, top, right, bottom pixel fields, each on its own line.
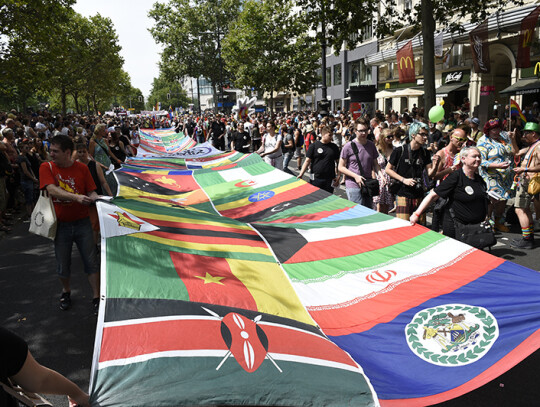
left=223, top=0, right=318, bottom=113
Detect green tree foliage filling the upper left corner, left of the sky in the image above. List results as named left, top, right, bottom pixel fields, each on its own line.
left=0, top=0, right=131, bottom=113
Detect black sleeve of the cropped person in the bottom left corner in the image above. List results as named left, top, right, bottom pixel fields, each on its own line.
left=0, top=327, right=28, bottom=406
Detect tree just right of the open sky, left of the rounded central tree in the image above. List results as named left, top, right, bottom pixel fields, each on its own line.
left=150, top=0, right=241, bottom=111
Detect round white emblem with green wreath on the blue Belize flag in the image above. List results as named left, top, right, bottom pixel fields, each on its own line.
left=405, top=304, right=499, bottom=367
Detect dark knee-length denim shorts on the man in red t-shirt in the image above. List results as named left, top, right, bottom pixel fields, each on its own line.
left=54, top=218, right=99, bottom=278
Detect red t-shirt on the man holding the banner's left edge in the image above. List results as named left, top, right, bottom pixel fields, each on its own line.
left=39, top=161, right=96, bottom=222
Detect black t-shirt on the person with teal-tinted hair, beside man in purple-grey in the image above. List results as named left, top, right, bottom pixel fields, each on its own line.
left=389, top=144, right=431, bottom=198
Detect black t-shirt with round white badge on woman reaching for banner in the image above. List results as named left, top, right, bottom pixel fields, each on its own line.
left=435, top=169, right=487, bottom=224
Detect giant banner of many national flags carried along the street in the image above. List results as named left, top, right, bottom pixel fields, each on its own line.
left=91, top=131, right=540, bottom=406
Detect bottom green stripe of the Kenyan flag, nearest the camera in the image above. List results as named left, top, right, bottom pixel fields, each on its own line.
left=90, top=355, right=375, bottom=407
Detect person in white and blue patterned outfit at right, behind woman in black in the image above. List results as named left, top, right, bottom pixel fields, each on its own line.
left=477, top=118, right=519, bottom=232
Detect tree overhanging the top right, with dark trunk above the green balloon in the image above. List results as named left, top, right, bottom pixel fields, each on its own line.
left=294, top=0, right=523, bottom=110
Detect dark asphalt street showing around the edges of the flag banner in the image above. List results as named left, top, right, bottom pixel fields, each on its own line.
left=0, top=177, right=540, bottom=407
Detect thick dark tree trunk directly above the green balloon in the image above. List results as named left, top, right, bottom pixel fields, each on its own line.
left=422, top=0, right=435, bottom=112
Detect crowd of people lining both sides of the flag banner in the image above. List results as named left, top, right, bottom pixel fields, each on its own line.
left=0, top=105, right=540, bottom=405
